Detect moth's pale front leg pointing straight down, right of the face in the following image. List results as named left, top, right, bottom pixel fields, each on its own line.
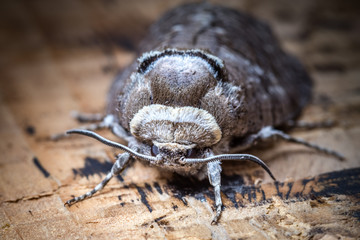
left=207, top=161, right=222, bottom=224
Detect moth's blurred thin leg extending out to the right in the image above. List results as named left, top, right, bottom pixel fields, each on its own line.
left=258, top=127, right=345, bottom=160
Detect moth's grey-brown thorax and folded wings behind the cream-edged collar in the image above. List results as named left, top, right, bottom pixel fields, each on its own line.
left=108, top=3, right=312, bottom=146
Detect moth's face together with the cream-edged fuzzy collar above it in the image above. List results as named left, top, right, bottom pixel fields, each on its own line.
left=130, top=104, right=221, bottom=162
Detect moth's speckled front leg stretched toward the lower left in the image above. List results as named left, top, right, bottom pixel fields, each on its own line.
left=64, top=153, right=130, bottom=206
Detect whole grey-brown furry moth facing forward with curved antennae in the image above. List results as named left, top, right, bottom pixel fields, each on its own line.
left=58, top=2, right=342, bottom=223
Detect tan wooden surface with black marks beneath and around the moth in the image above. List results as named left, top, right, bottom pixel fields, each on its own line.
left=0, top=0, right=360, bottom=239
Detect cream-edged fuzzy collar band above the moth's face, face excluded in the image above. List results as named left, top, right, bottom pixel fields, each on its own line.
left=130, top=104, right=222, bottom=148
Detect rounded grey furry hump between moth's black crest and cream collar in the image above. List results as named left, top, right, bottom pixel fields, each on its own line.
left=144, top=55, right=217, bottom=106
